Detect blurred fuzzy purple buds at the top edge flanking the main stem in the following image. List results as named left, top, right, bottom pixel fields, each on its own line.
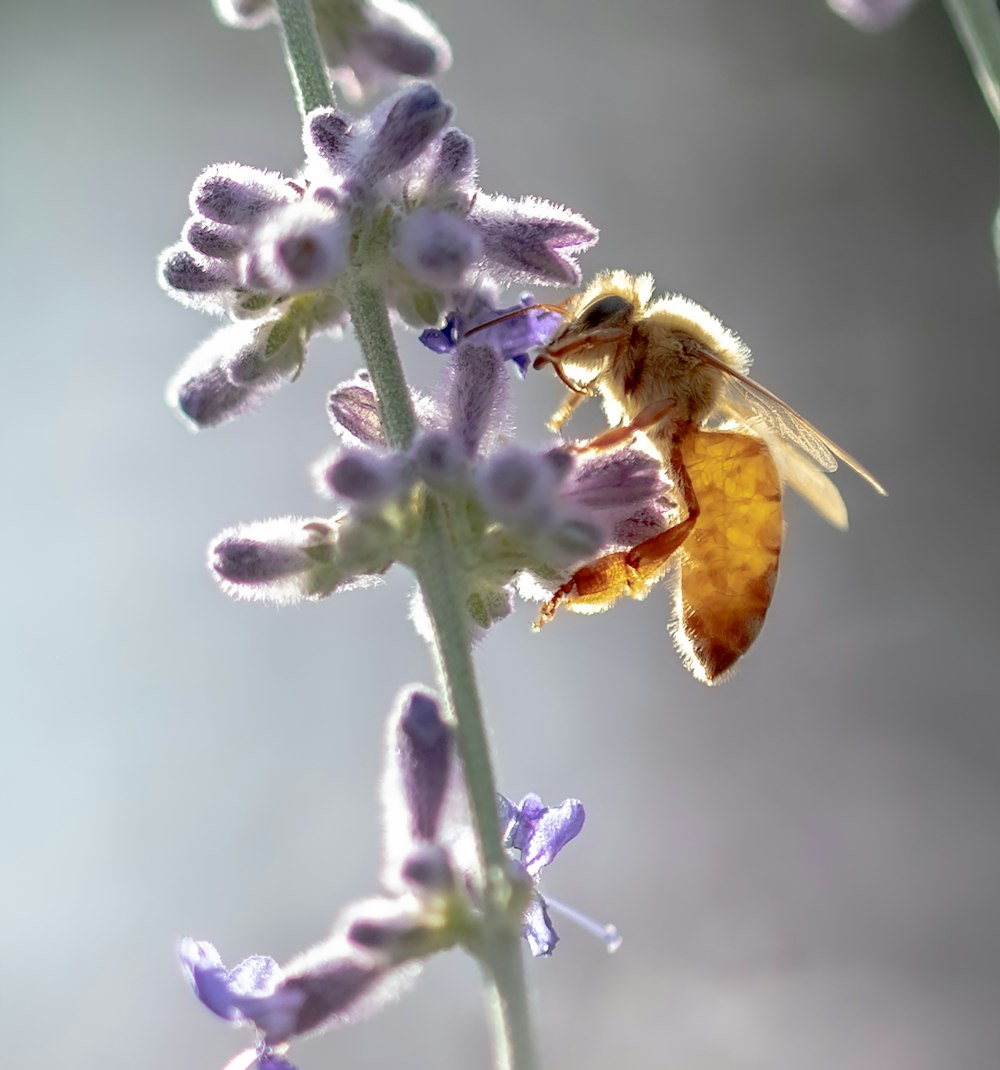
left=213, top=0, right=451, bottom=101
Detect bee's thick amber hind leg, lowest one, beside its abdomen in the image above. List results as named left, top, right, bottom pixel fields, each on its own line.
left=535, top=446, right=701, bottom=631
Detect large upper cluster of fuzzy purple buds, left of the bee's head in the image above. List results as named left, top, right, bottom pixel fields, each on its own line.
left=159, top=83, right=597, bottom=427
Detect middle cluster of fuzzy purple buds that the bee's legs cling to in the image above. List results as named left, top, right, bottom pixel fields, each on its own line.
left=210, top=315, right=676, bottom=633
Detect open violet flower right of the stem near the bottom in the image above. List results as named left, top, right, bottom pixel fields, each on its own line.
left=497, top=795, right=586, bottom=958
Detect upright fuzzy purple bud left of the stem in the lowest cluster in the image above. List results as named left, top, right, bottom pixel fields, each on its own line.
left=384, top=688, right=455, bottom=855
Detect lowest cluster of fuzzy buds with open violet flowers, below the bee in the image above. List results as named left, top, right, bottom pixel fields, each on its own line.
left=180, top=688, right=603, bottom=1070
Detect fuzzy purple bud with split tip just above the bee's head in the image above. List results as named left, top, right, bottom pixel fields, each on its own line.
left=468, top=194, right=598, bottom=286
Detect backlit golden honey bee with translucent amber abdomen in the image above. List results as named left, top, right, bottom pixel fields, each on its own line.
left=524, top=271, right=886, bottom=684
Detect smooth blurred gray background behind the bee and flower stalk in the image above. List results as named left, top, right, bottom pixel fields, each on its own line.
left=0, top=0, right=1000, bottom=1070
